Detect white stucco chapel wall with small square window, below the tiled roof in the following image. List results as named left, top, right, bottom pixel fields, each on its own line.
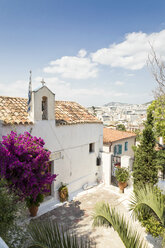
left=0, top=120, right=103, bottom=202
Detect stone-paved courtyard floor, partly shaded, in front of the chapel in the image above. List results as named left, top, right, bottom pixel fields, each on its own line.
left=31, top=186, right=162, bottom=248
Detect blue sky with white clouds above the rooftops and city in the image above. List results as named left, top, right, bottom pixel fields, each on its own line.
left=0, top=0, right=165, bottom=106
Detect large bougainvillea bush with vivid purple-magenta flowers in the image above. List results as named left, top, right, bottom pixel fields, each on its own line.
left=0, top=131, right=57, bottom=202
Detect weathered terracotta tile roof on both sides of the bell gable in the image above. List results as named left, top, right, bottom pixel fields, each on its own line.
left=0, top=96, right=102, bottom=125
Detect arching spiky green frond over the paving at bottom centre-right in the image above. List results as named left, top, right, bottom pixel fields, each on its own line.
left=93, top=202, right=148, bottom=248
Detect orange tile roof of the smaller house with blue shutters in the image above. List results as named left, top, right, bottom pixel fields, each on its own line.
left=103, top=128, right=136, bottom=144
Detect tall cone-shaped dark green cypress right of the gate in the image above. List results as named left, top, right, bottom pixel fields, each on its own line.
left=133, top=110, right=158, bottom=190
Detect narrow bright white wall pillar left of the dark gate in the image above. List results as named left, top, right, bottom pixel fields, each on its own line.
left=102, top=152, right=112, bottom=185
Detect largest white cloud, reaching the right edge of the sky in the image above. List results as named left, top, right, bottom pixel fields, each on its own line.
left=91, top=30, right=165, bottom=70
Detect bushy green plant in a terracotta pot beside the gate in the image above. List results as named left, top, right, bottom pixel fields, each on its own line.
left=115, top=168, right=129, bottom=193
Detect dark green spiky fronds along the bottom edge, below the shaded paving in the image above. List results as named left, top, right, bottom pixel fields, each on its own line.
left=28, top=221, right=90, bottom=248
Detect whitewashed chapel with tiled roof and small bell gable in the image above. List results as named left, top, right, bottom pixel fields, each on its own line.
left=0, top=80, right=103, bottom=206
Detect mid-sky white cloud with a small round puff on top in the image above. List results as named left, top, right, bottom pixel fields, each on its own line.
left=44, top=50, right=98, bottom=79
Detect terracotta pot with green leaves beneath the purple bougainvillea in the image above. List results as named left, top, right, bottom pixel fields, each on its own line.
left=25, top=193, right=44, bottom=217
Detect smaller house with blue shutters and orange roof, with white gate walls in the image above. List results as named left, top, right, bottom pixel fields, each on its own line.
left=102, top=128, right=136, bottom=185
